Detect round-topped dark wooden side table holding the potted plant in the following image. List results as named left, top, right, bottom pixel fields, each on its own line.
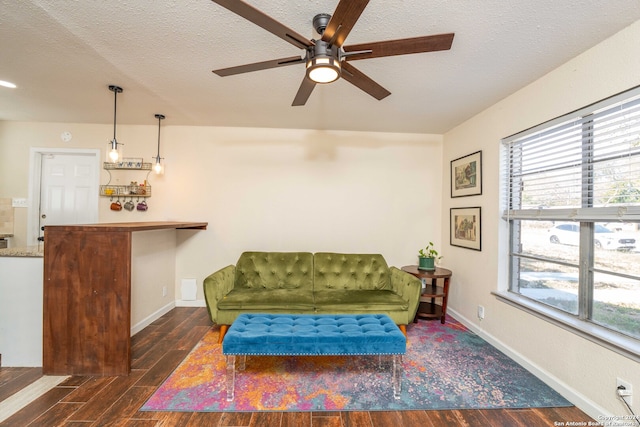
left=402, top=265, right=453, bottom=324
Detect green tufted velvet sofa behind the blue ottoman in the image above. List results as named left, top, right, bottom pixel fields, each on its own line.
left=203, top=252, right=422, bottom=340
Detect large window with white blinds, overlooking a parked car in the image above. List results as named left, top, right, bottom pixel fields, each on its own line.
left=502, top=87, right=640, bottom=357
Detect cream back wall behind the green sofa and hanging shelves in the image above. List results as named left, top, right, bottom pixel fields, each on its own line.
left=0, top=122, right=443, bottom=300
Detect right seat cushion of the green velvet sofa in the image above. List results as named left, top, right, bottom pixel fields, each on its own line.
left=314, top=290, right=409, bottom=313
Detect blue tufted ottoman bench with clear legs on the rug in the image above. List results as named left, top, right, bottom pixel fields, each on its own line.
left=222, top=314, right=407, bottom=401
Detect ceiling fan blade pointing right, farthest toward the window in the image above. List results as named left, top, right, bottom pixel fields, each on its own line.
left=344, top=33, right=454, bottom=61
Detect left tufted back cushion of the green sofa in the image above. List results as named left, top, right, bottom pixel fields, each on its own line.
left=235, top=252, right=313, bottom=290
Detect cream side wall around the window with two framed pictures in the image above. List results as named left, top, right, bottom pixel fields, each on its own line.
left=441, top=22, right=640, bottom=417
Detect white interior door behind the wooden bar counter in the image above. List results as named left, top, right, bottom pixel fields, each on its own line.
left=33, top=152, right=100, bottom=244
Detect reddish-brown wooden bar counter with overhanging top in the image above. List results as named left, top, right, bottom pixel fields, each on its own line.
left=43, top=221, right=207, bottom=376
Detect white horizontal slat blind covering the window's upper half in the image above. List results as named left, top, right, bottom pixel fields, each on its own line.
left=503, top=88, right=640, bottom=221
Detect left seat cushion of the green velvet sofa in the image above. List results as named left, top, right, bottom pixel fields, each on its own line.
left=218, top=289, right=314, bottom=313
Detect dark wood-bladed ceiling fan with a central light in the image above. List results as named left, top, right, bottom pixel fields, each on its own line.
left=212, top=0, right=454, bottom=106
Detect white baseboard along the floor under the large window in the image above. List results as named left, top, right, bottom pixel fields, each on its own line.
left=447, top=308, right=612, bottom=420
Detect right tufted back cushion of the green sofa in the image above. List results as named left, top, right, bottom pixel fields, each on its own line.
left=314, top=252, right=391, bottom=291
